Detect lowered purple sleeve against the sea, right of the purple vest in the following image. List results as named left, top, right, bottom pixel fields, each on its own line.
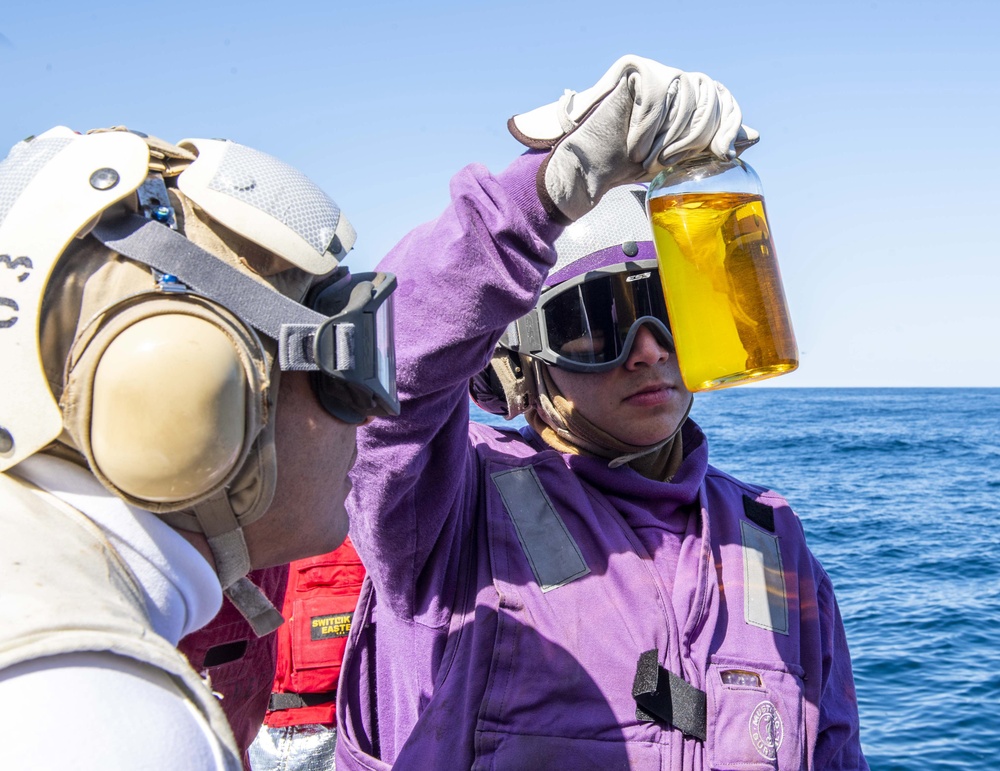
left=813, top=575, right=868, bottom=771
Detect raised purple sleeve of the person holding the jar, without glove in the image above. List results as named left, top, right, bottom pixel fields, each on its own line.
left=349, top=153, right=561, bottom=624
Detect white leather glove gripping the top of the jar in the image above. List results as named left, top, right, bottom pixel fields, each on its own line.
left=507, top=56, right=760, bottom=222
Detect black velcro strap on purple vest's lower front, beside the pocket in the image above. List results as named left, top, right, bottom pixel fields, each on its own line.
left=632, top=648, right=708, bottom=741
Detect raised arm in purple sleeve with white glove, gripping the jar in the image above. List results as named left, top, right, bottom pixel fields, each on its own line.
left=351, top=56, right=756, bottom=615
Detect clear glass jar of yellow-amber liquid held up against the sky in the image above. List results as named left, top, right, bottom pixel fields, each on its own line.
left=646, top=156, right=798, bottom=392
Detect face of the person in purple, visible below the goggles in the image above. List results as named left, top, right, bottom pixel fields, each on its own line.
left=549, top=325, right=691, bottom=445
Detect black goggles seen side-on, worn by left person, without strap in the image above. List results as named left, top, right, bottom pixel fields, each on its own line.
left=306, top=268, right=399, bottom=423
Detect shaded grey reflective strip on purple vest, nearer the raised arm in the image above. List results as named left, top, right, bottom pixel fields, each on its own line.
left=492, top=466, right=590, bottom=592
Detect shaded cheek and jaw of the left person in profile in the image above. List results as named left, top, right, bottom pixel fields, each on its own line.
left=244, top=372, right=357, bottom=568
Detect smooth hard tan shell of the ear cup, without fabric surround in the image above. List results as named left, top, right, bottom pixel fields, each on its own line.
left=90, top=313, right=247, bottom=503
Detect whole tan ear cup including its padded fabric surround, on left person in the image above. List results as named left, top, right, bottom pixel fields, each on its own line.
left=62, top=292, right=270, bottom=531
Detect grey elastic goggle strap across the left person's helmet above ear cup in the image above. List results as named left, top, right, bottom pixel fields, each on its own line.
left=92, top=215, right=328, bottom=369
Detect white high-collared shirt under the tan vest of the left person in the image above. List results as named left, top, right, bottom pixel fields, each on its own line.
left=0, top=455, right=232, bottom=771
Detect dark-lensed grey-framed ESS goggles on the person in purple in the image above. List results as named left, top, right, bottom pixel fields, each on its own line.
left=500, top=260, right=674, bottom=372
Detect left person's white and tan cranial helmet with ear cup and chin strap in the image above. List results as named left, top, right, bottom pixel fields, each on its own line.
left=0, top=127, right=355, bottom=631
